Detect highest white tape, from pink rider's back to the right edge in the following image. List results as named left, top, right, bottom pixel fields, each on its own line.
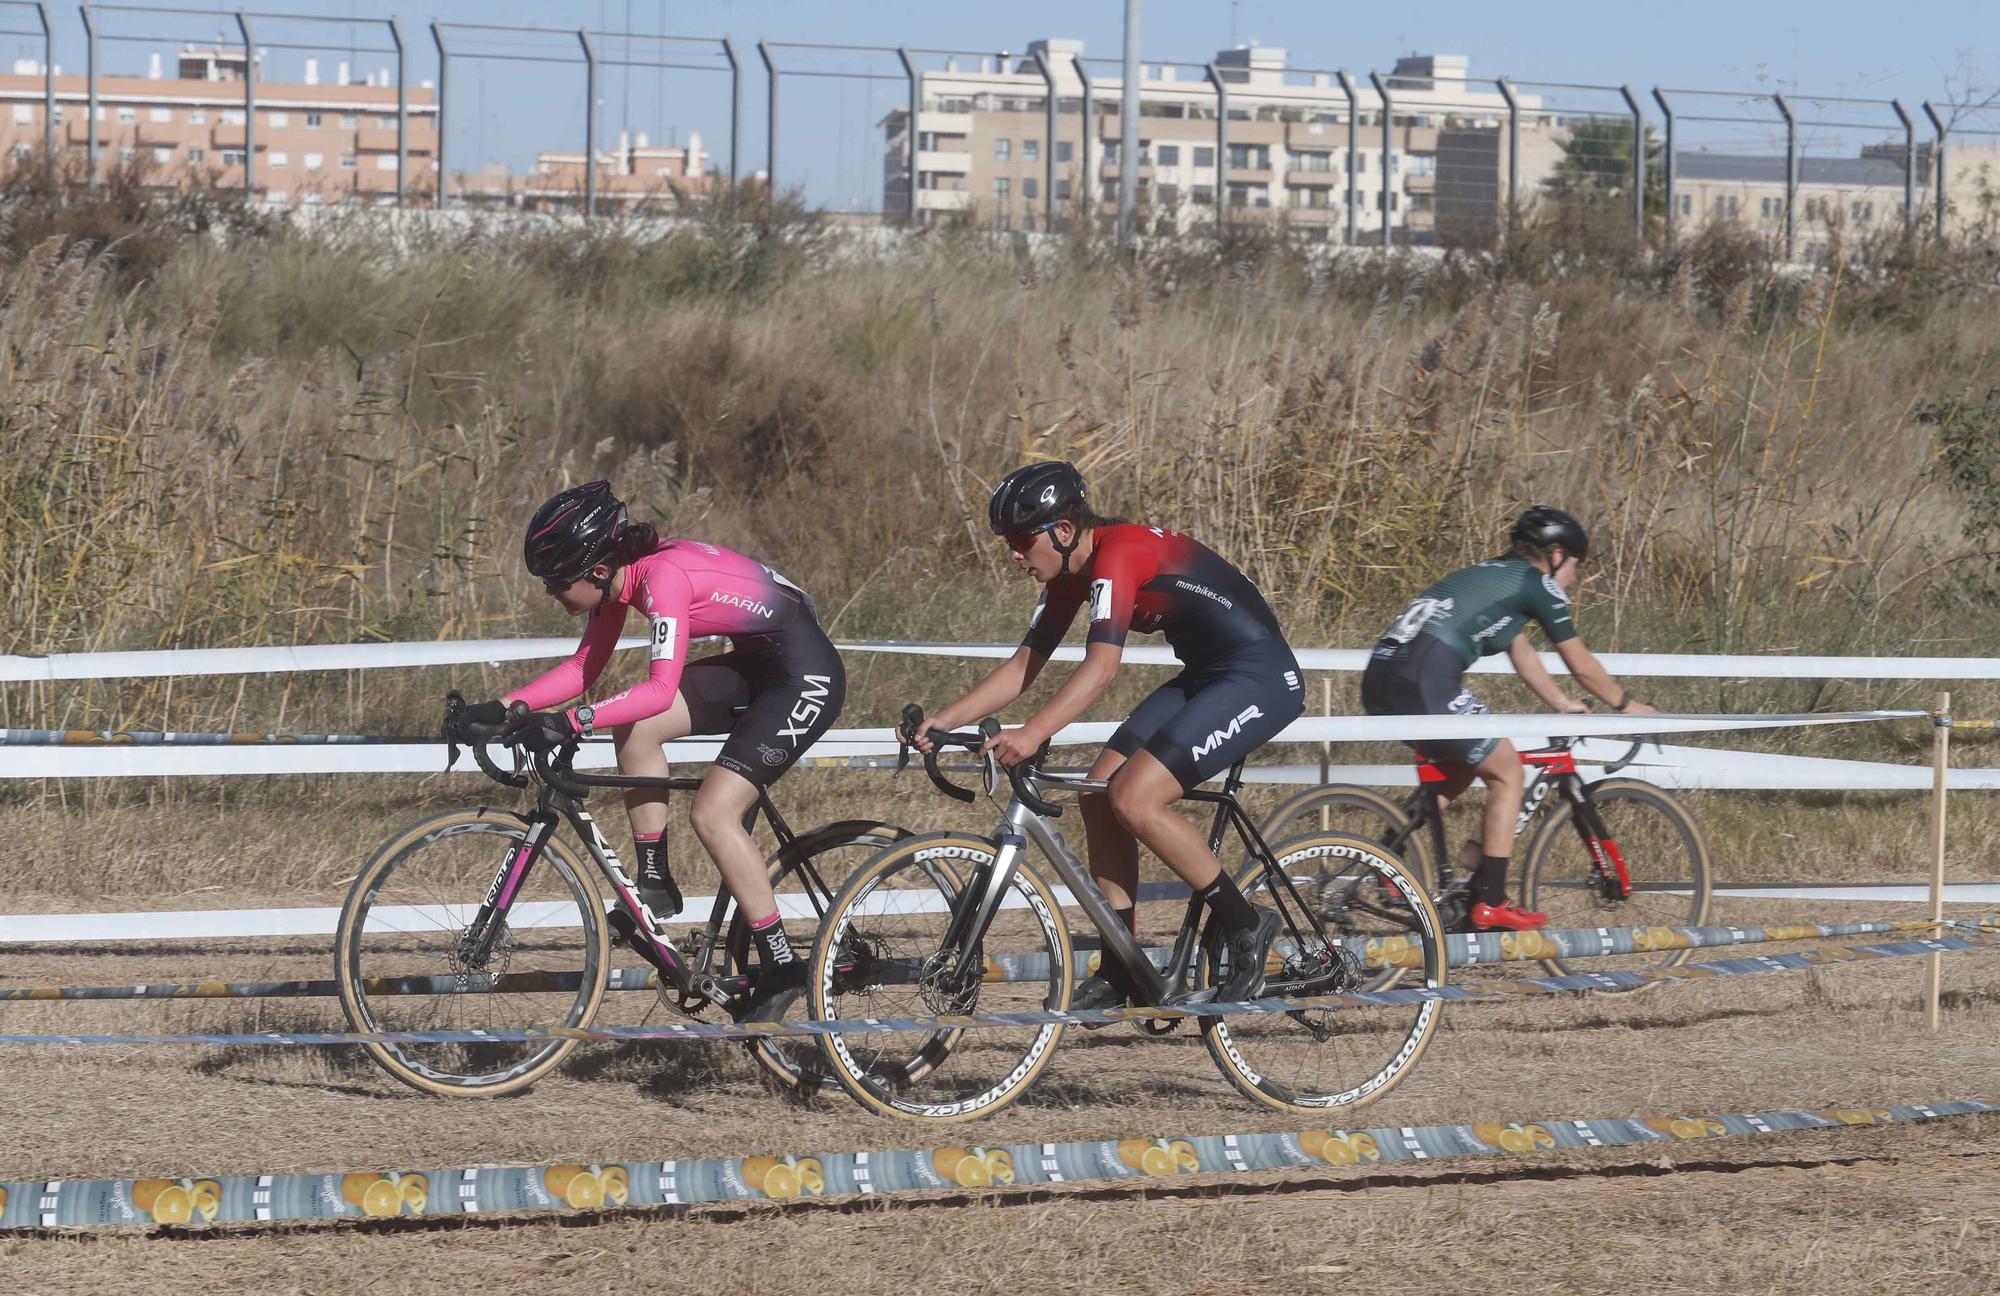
left=840, top=640, right=2000, bottom=680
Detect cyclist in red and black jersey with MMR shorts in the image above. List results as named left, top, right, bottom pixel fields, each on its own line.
left=916, top=462, right=1304, bottom=1008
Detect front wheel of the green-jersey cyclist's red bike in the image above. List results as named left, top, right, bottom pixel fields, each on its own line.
left=1522, top=778, right=1708, bottom=990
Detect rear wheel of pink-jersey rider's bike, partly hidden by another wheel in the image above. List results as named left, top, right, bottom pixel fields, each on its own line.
left=732, top=820, right=910, bottom=1092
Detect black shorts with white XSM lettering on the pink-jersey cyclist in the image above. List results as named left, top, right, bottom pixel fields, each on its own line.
left=680, top=614, right=848, bottom=788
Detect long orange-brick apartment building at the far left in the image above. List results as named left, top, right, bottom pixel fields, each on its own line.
left=0, top=46, right=438, bottom=202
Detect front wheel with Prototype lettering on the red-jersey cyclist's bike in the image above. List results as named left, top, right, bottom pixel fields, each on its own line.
left=812, top=832, right=1074, bottom=1122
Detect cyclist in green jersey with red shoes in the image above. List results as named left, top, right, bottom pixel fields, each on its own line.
left=1362, top=506, right=1658, bottom=932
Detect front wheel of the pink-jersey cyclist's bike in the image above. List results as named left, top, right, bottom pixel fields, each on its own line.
left=334, top=808, right=610, bottom=1098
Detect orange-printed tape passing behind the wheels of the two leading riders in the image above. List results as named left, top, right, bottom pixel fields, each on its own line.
left=0, top=914, right=2000, bottom=1004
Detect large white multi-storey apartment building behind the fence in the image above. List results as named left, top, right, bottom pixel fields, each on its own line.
left=882, top=40, right=1564, bottom=242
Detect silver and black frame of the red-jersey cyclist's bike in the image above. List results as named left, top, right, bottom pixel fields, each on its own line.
left=940, top=764, right=1324, bottom=1006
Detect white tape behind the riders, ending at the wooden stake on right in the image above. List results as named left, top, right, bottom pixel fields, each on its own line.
left=0, top=710, right=1928, bottom=786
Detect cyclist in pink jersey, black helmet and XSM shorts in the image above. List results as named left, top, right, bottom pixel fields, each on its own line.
left=466, top=482, right=846, bottom=1016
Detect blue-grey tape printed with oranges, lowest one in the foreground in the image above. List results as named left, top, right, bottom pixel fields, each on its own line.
left=0, top=1100, right=2000, bottom=1230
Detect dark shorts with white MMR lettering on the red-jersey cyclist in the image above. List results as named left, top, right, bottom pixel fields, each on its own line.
left=1104, top=640, right=1306, bottom=792
